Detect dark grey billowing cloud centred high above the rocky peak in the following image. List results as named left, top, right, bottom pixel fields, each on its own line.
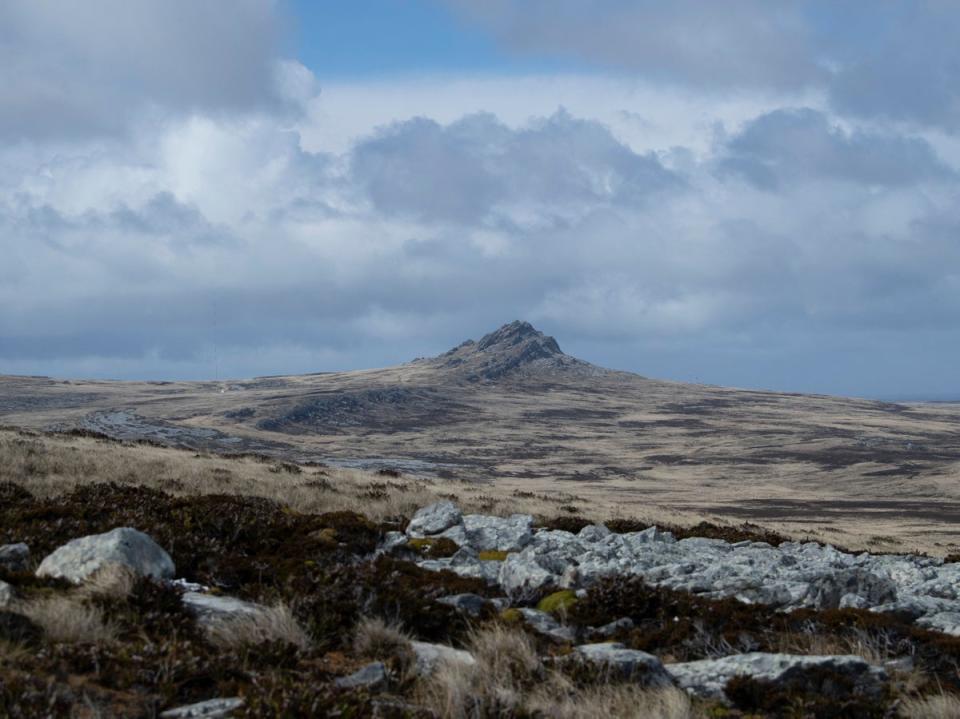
left=351, top=110, right=681, bottom=222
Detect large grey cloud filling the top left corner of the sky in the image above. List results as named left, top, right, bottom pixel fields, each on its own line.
left=0, top=0, right=292, bottom=140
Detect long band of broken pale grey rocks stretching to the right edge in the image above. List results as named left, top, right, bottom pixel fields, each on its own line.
left=418, top=503, right=960, bottom=636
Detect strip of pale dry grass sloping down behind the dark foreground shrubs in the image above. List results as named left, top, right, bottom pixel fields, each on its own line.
left=0, top=430, right=700, bottom=521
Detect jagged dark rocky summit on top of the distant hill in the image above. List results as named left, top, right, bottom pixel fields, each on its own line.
left=431, top=320, right=604, bottom=381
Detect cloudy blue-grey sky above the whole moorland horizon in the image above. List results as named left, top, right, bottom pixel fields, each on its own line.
left=0, top=0, right=960, bottom=399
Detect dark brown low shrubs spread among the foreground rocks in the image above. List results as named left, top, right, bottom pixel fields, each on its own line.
left=0, top=483, right=960, bottom=719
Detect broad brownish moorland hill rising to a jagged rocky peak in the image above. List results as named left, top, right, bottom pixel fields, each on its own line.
left=0, top=321, right=960, bottom=536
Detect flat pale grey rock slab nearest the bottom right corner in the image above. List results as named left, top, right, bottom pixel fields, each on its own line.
left=665, top=652, right=887, bottom=700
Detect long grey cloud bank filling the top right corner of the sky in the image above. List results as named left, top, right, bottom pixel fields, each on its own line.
left=445, top=0, right=960, bottom=132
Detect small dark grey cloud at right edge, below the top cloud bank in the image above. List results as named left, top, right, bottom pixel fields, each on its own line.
left=720, top=108, right=956, bottom=190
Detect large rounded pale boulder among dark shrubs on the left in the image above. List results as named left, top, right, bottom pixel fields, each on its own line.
left=37, top=527, right=175, bottom=584
